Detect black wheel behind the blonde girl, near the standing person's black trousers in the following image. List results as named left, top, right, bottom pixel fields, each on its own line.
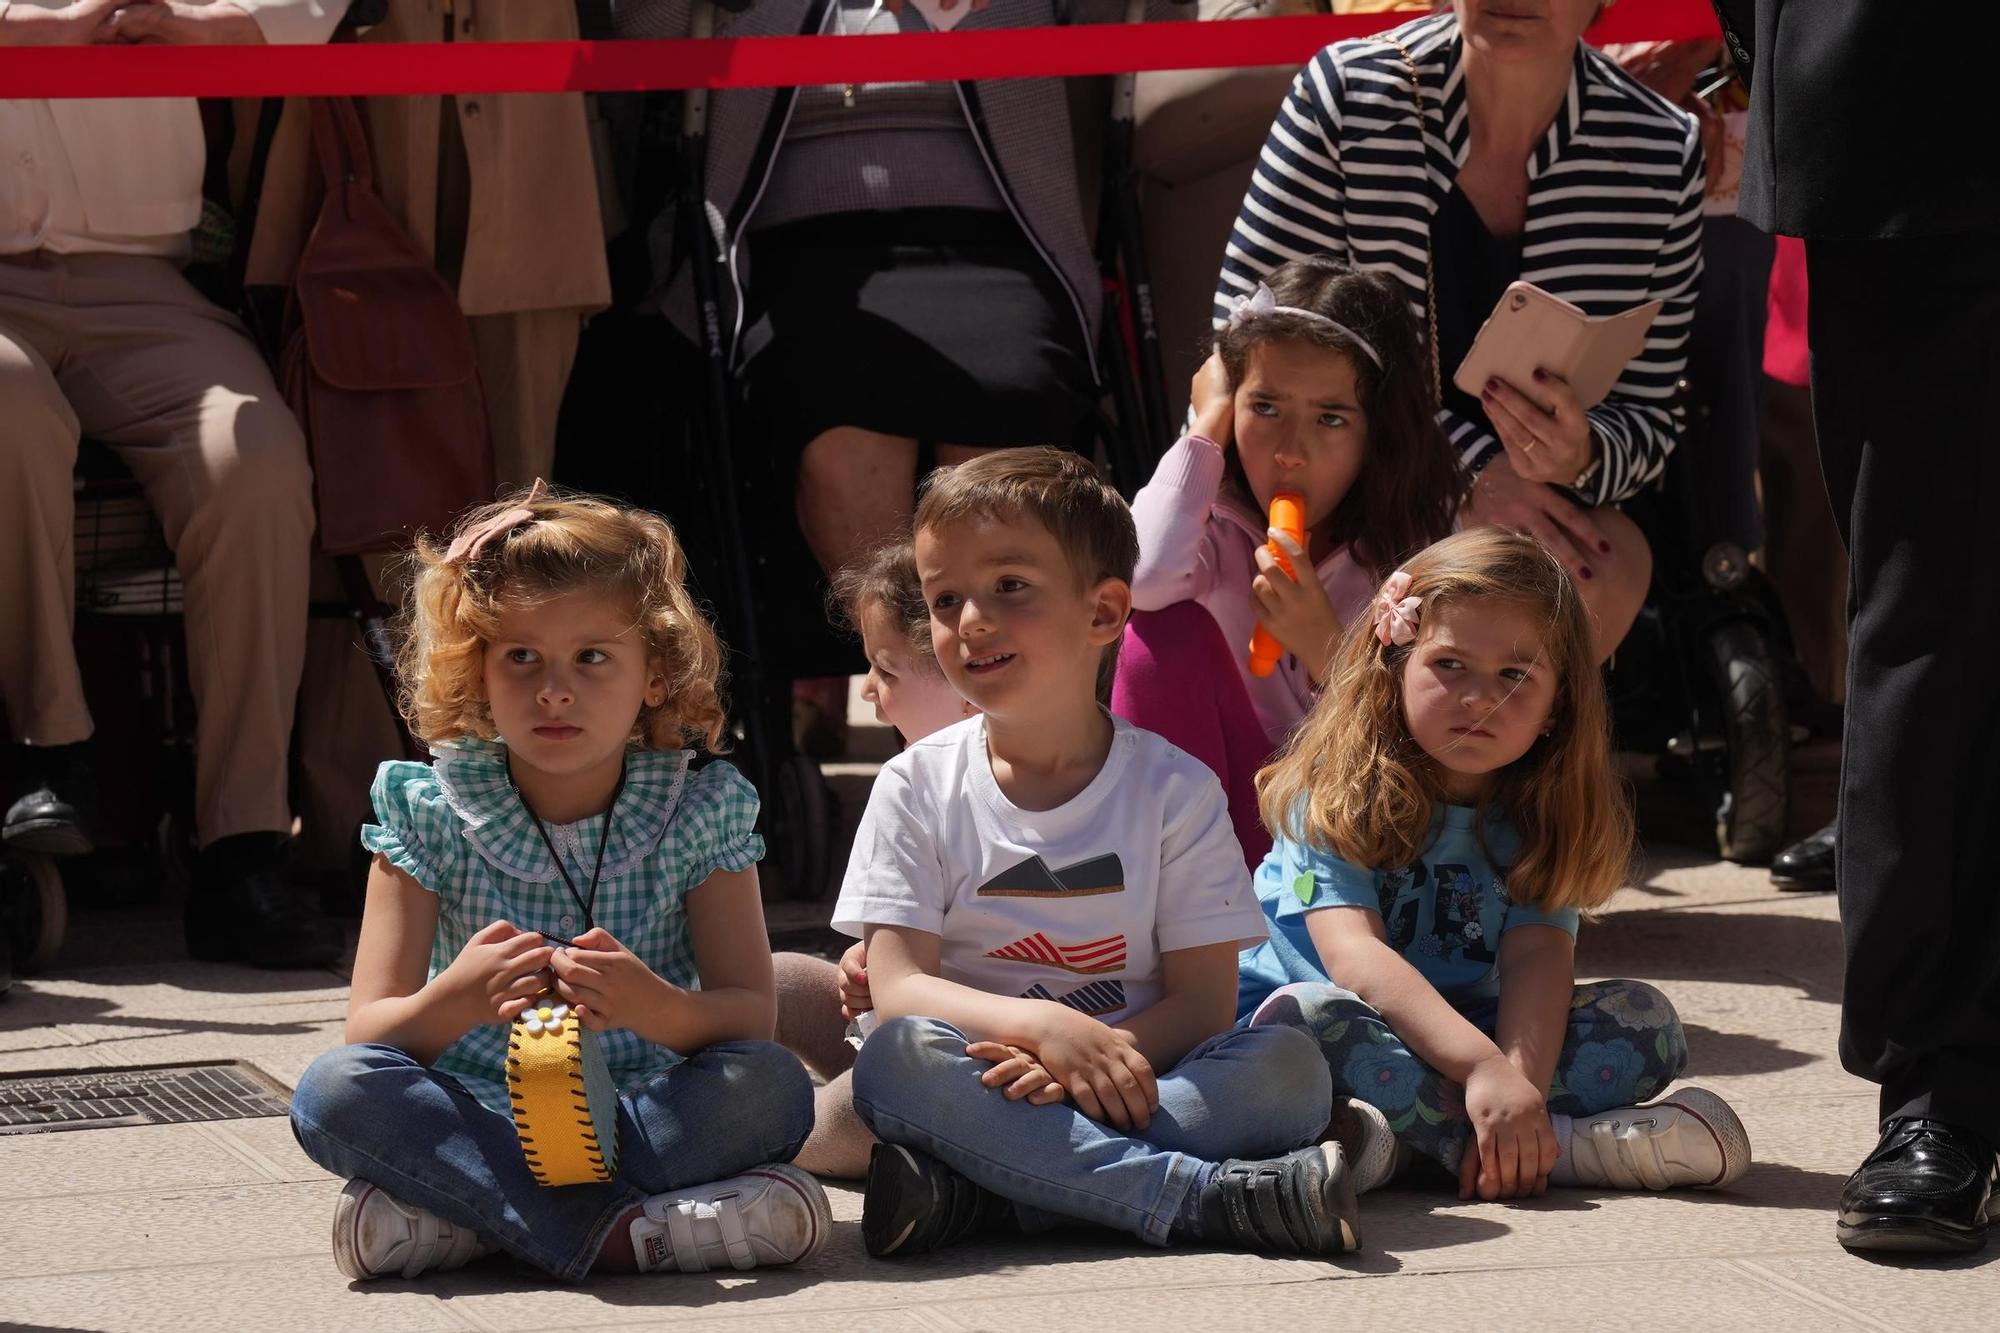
left=1694, top=620, right=1792, bottom=863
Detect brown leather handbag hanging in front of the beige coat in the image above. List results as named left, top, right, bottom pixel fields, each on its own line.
left=278, top=98, right=494, bottom=554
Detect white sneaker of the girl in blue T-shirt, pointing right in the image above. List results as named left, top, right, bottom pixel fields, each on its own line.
left=1568, top=1087, right=1750, bottom=1189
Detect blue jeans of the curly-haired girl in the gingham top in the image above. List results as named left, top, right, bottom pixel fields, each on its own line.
left=292, top=1041, right=812, bottom=1281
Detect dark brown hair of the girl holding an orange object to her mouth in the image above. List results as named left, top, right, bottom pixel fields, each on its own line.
left=1216, top=254, right=1466, bottom=578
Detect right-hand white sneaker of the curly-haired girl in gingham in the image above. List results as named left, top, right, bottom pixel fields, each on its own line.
left=632, top=1163, right=834, bottom=1273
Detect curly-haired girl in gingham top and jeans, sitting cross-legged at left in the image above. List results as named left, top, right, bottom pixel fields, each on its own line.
left=292, top=482, right=830, bottom=1279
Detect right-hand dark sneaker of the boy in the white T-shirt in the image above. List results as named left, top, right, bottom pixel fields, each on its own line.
left=1202, top=1143, right=1362, bottom=1255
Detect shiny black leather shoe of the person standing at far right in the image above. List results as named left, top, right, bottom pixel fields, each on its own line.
left=1834, top=1119, right=2000, bottom=1251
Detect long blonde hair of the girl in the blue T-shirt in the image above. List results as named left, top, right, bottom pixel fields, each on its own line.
left=1256, top=528, right=1632, bottom=911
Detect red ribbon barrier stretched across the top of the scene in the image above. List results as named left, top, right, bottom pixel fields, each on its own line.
left=0, top=0, right=1720, bottom=98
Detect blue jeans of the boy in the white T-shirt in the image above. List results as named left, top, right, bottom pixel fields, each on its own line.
left=854, top=1019, right=1332, bottom=1245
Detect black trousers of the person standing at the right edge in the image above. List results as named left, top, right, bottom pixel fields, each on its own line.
left=1806, top=228, right=2000, bottom=1145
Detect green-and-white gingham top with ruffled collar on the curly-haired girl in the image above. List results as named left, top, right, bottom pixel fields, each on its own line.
left=362, top=739, right=764, bottom=1115
